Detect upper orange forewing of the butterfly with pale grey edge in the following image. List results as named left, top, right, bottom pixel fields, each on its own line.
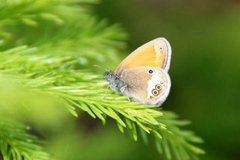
left=115, top=38, right=171, bottom=73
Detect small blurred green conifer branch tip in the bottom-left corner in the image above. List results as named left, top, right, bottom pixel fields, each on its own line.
left=0, top=120, right=50, bottom=160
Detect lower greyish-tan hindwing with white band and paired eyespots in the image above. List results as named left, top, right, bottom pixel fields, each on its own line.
left=121, top=67, right=171, bottom=105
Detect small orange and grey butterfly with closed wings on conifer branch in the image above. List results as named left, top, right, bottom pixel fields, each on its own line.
left=104, top=37, right=172, bottom=106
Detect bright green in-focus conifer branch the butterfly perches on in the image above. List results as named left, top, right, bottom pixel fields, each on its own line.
left=0, top=47, right=204, bottom=160
